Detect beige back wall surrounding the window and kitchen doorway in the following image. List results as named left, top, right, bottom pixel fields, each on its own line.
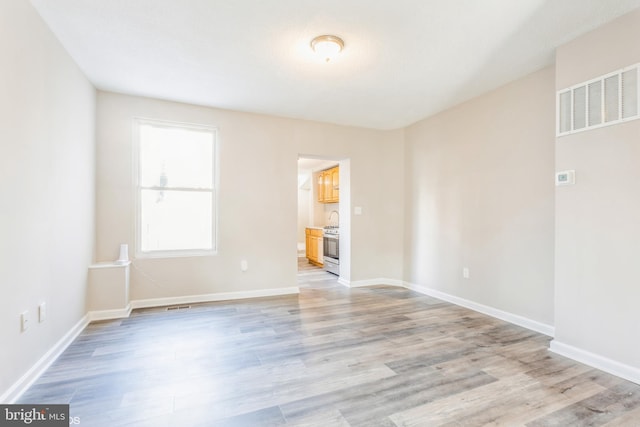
left=97, top=92, right=403, bottom=300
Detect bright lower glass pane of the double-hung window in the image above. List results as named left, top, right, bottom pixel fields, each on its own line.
left=140, top=190, right=213, bottom=252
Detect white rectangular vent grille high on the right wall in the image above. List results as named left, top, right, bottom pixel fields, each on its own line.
left=556, top=64, right=640, bottom=136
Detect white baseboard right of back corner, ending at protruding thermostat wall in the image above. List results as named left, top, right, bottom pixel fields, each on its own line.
left=404, top=282, right=555, bottom=337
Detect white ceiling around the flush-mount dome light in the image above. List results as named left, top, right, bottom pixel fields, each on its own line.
left=31, top=0, right=640, bottom=129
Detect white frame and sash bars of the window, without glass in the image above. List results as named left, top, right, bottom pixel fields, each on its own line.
left=133, top=117, right=219, bottom=258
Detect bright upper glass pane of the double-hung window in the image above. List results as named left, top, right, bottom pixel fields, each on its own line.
left=140, top=124, right=213, bottom=189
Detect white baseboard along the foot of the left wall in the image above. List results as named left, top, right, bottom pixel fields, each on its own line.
left=0, top=315, right=89, bottom=403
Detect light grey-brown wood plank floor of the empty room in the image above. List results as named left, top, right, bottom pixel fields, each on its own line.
left=21, top=269, right=640, bottom=427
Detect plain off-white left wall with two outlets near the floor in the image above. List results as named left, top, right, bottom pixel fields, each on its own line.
left=0, top=0, right=95, bottom=401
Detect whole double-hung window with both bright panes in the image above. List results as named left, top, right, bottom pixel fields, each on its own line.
left=135, top=119, right=216, bottom=257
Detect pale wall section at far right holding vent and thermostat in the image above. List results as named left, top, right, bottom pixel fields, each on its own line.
left=553, top=10, right=640, bottom=381
